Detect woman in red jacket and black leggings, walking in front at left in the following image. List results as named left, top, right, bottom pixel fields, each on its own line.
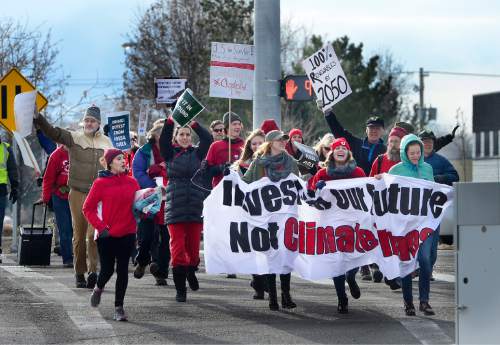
left=83, top=149, right=139, bottom=321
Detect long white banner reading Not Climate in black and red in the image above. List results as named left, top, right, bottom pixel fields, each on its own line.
left=203, top=172, right=453, bottom=280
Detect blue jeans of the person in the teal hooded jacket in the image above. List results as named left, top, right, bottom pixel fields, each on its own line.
left=402, top=231, right=439, bottom=303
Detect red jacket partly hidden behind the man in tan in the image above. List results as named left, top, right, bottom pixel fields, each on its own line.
left=42, top=146, right=69, bottom=203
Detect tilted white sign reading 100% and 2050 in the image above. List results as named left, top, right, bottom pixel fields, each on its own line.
left=302, top=44, right=352, bottom=111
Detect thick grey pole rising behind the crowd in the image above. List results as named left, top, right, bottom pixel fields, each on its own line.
left=253, top=0, right=281, bottom=128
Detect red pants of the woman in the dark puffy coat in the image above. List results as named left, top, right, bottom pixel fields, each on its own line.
left=168, top=222, right=203, bottom=267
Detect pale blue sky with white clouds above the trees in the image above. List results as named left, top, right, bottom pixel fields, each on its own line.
left=0, top=0, right=500, bottom=130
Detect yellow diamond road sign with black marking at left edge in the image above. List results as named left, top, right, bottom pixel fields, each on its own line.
left=0, top=68, right=48, bottom=131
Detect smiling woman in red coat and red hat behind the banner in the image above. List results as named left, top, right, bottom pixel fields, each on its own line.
left=309, top=138, right=366, bottom=314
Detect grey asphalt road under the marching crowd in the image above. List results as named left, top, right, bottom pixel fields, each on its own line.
left=0, top=243, right=455, bottom=344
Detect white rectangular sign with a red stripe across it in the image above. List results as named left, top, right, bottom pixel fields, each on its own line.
left=210, top=42, right=255, bottom=100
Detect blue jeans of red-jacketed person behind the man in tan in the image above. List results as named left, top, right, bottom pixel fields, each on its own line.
left=52, top=194, right=73, bottom=264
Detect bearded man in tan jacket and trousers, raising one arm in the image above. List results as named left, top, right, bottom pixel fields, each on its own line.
left=34, top=105, right=113, bottom=289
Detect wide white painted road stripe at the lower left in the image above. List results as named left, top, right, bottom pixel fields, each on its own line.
left=0, top=259, right=118, bottom=344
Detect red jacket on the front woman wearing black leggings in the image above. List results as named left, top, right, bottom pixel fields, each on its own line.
left=83, top=171, right=140, bottom=237
